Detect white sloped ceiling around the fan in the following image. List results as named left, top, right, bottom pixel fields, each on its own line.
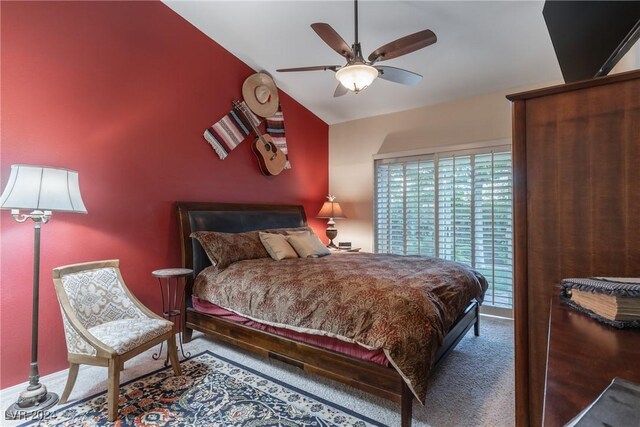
left=165, top=0, right=562, bottom=124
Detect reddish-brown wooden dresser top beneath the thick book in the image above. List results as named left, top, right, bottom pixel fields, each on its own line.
left=543, top=291, right=640, bottom=427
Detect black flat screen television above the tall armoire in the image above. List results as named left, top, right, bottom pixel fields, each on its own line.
left=542, top=0, right=640, bottom=83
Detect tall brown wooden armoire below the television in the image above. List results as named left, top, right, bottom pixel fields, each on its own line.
left=507, top=71, right=640, bottom=426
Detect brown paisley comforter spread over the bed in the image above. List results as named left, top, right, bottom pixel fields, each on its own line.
left=194, top=253, right=487, bottom=403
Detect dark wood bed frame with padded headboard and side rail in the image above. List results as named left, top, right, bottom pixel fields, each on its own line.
left=177, top=202, right=480, bottom=427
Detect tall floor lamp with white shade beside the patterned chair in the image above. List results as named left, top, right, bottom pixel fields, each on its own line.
left=0, top=165, right=87, bottom=419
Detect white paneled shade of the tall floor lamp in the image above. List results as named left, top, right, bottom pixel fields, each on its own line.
left=0, top=165, right=87, bottom=213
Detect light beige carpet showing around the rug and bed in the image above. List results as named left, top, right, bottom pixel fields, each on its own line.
left=0, top=316, right=515, bottom=427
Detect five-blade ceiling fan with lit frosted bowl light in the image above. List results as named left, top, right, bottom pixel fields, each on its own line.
left=276, top=0, right=437, bottom=97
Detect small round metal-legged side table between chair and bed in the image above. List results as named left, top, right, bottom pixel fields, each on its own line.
left=151, top=268, right=193, bottom=366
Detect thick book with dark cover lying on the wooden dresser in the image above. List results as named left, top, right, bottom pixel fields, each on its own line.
left=560, top=277, right=640, bottom=328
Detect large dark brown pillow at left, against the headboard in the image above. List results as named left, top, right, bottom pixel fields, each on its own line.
left=190, top=231, right=269, bottom=270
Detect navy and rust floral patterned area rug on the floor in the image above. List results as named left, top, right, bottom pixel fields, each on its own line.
left=22, top=351, right=383, bottom=427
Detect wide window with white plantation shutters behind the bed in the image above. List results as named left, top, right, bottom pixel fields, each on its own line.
left=375, top=146, right=513, bottom=309
